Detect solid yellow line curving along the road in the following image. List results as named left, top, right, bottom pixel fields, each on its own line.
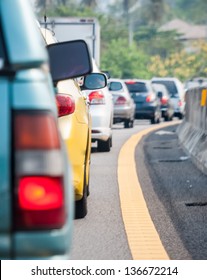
left=118, top=121, right=180, bottom=260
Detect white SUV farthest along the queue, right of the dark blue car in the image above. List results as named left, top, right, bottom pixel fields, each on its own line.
left=152, top=77, right=185, bottom=119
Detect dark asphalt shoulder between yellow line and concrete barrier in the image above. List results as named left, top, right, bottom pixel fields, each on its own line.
left=136, top=126, right=207, bottom=260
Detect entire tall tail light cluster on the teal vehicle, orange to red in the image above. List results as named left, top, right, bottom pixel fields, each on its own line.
left=13, top=111, right=66, bottom=230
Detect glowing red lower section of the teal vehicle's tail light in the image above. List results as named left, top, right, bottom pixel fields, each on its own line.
left=15, top=176, right=66, bottom=229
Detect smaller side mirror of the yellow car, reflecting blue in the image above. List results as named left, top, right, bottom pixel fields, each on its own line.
left=81, top=73, right=107, bottom=90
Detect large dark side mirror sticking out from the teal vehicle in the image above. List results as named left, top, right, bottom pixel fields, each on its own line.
left=47, top=40, right=92, bottom=83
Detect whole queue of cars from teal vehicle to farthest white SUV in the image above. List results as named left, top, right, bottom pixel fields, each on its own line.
left=0, top=0, right=188, bottom=259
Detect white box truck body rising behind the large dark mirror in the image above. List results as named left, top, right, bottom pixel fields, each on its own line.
left=40, top=17, right=100, bottom=66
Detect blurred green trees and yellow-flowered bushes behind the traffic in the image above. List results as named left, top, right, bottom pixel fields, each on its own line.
left=36, top=0, right=207, bottom=81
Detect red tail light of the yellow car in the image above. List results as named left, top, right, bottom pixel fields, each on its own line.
left=56, top=93, right=75, bottom=117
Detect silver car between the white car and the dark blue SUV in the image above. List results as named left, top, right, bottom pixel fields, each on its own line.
left=108, top=79, right=136, bottom=128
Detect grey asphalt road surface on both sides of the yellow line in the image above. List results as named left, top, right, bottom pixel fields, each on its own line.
left=71, top=121, right=207, bottom=260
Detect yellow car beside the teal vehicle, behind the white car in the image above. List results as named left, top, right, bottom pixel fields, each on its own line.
left=41, top=28, right=91, bottom=218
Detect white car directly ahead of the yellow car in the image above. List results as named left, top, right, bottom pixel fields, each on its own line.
left=81, top=60, right=114, bottom=152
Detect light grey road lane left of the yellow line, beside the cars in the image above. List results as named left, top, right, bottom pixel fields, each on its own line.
left=71, top=121, right=150, bottom=260
